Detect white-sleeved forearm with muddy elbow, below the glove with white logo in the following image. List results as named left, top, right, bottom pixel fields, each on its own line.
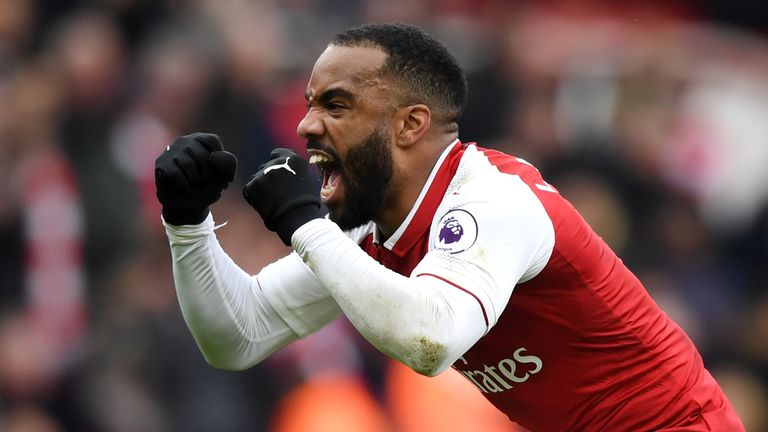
left=292, top=219, right=485, bottom=375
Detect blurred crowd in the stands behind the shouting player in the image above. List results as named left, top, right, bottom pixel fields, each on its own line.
left=0, top=0, right=768, bottom=432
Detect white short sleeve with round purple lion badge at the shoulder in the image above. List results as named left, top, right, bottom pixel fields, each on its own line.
left=413, top=175, right=555, bottom=330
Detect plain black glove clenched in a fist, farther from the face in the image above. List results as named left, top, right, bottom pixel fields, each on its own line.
left=155, top=133, right=237, bottom=225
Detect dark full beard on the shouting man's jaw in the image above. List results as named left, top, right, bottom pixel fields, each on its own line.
left=329, top=123, right=394, bottom=231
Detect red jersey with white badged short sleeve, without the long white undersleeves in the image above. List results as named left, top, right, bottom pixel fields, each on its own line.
left=353, top=142, right=741, bottom=431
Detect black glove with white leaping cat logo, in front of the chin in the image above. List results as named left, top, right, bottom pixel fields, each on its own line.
left=243, top=148, right=324, bottom=246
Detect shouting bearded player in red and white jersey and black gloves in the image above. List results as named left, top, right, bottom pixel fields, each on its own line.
left=156, top=24, right=743, bottom=431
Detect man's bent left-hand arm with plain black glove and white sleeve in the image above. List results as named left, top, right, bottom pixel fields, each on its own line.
left=155, top=133, right=340, bottom=369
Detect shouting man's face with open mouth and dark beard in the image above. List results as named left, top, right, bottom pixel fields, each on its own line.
left=298, top=46, right=395, bottom=230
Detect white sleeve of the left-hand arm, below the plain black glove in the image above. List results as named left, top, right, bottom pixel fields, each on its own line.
left=163, top=215, right=340, bottom=370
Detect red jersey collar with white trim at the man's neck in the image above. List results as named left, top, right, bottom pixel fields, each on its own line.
left=374, top=139, right=464, bottom=257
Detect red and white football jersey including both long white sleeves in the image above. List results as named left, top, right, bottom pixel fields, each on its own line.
left=166, top=141, right=744, bottom=431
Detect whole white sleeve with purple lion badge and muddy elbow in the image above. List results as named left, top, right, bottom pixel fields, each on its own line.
left=292, top=174, right=554, bottom=375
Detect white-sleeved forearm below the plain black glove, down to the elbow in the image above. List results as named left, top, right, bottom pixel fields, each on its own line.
left=165, top=215, right=296, bottom=370
